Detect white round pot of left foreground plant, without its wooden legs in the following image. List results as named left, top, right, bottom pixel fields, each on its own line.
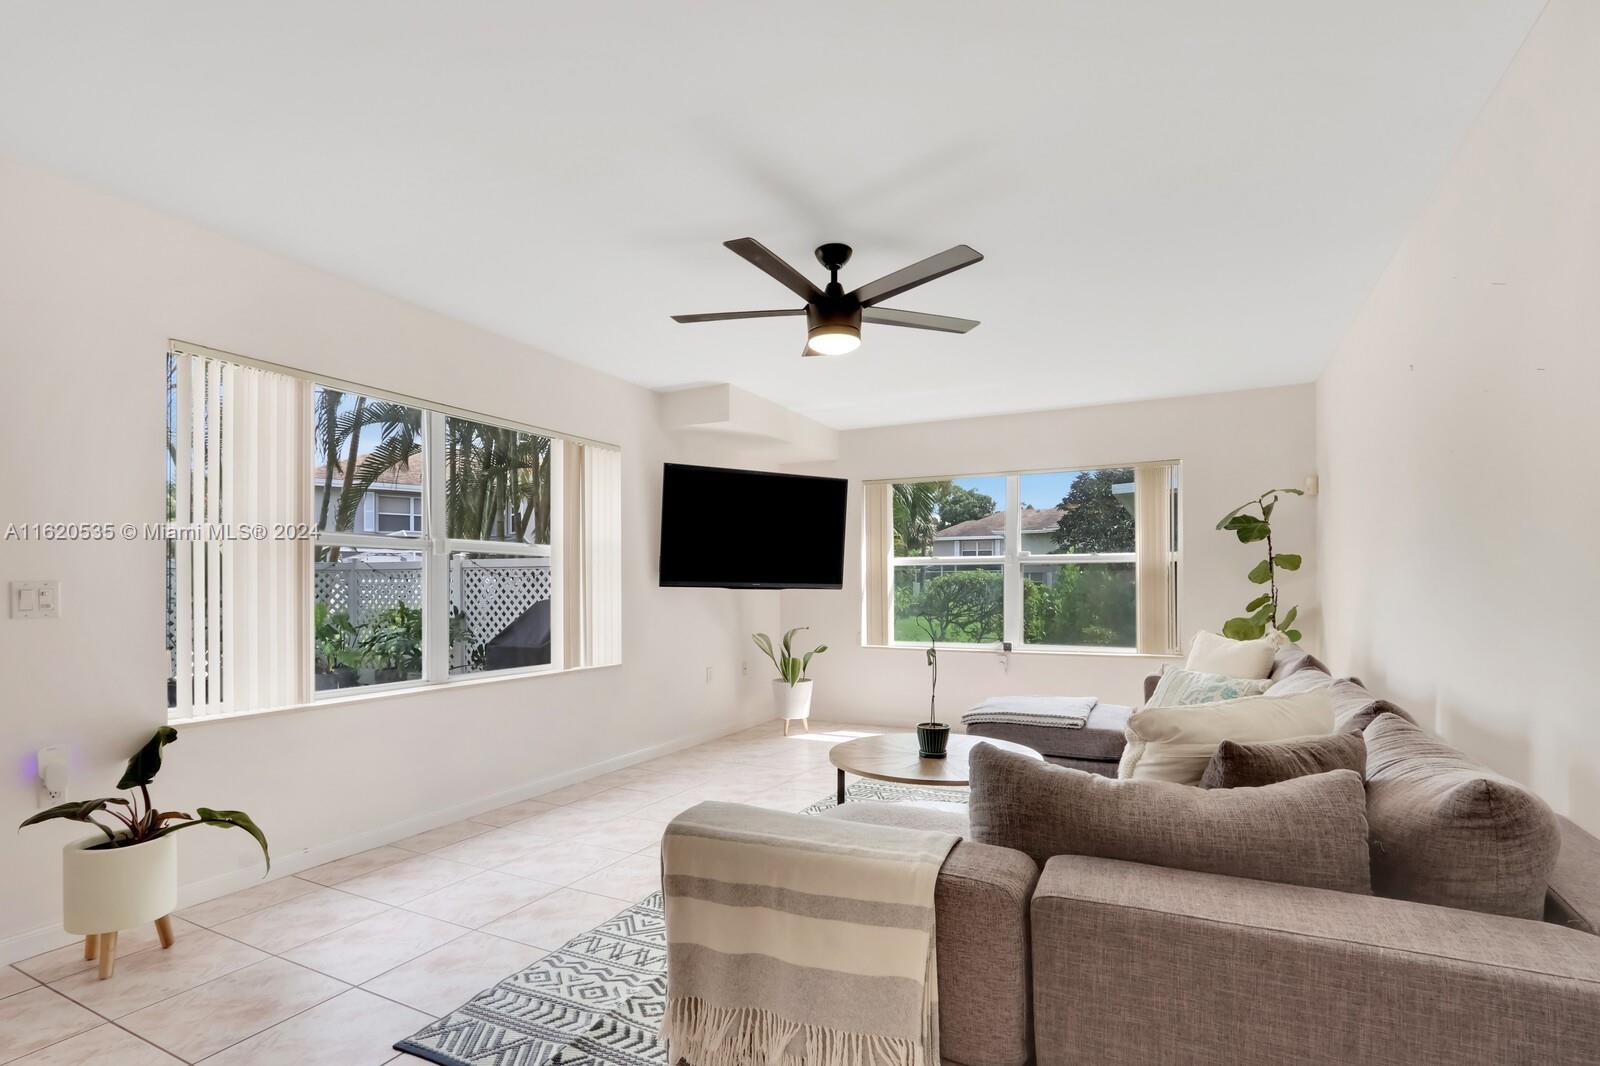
left=61, top=836, right=178, bottom=936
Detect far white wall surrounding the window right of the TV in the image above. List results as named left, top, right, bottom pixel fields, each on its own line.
left=780, top=385, right=1320, bottom=725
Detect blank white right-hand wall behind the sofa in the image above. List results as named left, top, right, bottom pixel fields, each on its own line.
left=1317, top=0, right=1600, bottom=831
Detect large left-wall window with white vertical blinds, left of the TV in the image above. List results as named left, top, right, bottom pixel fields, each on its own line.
left=166, top=343, right=622, bottom=719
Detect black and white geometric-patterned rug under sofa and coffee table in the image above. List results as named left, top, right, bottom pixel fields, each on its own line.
left=395, top=781, right=968, bottom=1066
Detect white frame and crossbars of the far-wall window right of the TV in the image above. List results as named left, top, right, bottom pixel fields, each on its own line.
left=883, top=459, right=1182, bottom=655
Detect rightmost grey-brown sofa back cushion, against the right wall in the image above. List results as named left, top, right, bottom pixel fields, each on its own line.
left=1363, top=714, right=1560, bottom=919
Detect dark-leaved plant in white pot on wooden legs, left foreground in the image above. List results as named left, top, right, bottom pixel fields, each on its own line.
left=18, top=725, right=272, bottom=980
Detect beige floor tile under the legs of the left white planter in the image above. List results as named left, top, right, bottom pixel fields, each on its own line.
left=51, top=921, right=265, bottom=1021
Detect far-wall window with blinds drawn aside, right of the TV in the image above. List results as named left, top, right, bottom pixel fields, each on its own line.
left=867, top=463, right=1178, bottom=653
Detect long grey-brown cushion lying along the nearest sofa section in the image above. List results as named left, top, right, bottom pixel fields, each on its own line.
left=968, top=744, right=1371, bottom=895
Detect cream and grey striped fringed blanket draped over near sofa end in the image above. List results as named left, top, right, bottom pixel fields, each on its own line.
left=661, top=802, right=957, bottom=1066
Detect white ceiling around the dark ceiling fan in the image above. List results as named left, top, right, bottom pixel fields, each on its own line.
left=0, top=0, right=1542, bottom=427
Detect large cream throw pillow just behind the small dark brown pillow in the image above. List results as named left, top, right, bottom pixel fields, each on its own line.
left=1117, top=688, right=1333, bottom=784
